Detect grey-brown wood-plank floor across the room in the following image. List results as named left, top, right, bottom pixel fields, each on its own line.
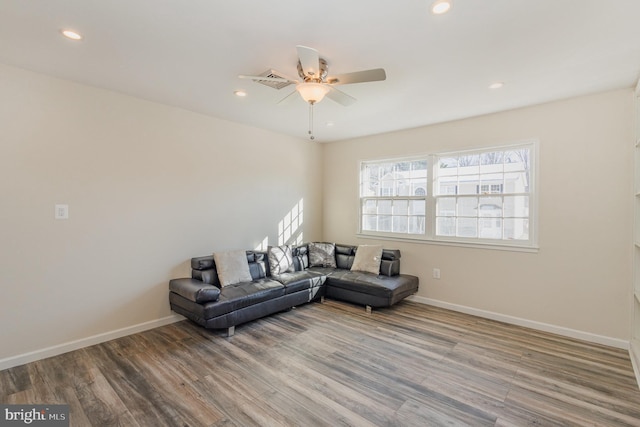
left=0, top=300, right=640, bottom=427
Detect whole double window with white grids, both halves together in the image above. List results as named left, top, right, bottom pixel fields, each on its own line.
left=360, top=142, right=536, bottom=247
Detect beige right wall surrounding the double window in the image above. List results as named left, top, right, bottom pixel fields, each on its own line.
left=323, top=89, right=633, bottom=342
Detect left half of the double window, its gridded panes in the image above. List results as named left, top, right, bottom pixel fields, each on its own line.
left=360, top=159, right=427, bottom=235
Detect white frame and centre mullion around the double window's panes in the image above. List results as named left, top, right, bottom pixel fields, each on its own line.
left=358, top=140, right=539, bottom=251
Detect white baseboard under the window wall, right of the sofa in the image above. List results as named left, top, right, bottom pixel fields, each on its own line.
left=407, top=295, right=629, bottom=350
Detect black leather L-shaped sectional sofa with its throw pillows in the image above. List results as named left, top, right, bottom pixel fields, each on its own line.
left=169, top=242, right=419, bottom=336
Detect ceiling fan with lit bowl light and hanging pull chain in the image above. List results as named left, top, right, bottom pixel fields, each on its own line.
left=238, top=45, right=387, bottom=139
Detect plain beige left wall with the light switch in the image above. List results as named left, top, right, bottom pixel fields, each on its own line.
left=0, top=65, right=322, bottom=365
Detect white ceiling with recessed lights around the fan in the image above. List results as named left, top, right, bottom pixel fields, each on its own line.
left=0, top=0, right=640, bottom=142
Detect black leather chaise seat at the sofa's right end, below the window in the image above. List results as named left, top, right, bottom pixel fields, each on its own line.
left=327, top=271, right=418, bottom=298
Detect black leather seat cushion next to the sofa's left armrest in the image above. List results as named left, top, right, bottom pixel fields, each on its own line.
left=203, top=279, right=284, bottom=319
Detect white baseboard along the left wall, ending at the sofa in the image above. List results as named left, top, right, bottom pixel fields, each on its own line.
left=0, top=314, right=185, bottom=371
